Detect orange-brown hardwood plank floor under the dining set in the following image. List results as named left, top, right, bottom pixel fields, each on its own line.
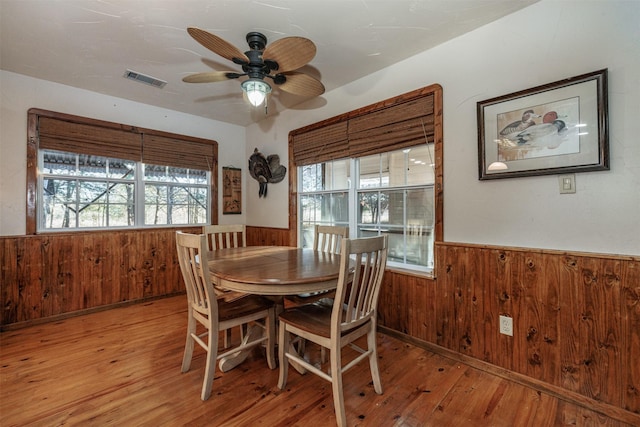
left=0, top=296, right=626, bottom=427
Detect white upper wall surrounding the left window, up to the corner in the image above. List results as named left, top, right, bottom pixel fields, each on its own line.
left=0, top=71, right=246, bottom=236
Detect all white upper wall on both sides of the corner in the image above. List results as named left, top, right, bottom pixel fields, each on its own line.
left=0, top=0, right=640, bottom=255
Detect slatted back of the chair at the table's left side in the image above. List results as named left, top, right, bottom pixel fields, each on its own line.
left=176, top=231, right=218, bottom=316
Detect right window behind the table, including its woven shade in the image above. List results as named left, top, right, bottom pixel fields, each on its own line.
left=289, top=84, right=444, bottom=275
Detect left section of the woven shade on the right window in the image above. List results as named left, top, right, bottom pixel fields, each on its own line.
left=293, top=121, right=349, bottom=166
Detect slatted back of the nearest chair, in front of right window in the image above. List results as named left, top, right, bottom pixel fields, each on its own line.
left=331, top=235, right=389, bottom=334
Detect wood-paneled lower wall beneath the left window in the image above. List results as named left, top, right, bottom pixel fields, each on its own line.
left=0, top=227, right=200, bottom=328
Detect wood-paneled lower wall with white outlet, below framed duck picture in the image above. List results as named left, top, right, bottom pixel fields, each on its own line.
left=379, top=243, right=640, bottom=420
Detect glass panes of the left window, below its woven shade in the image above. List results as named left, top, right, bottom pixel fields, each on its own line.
left=38, top=150, right=210, bottom=231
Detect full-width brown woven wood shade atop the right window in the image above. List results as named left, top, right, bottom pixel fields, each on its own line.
left=292, top=92, right=435, bottom=166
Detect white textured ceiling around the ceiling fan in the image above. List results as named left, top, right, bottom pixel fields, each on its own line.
left=0, top=0, right=538, bottom=126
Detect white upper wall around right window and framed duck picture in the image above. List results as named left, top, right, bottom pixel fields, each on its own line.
left=246, top=0, right=640, bottom=255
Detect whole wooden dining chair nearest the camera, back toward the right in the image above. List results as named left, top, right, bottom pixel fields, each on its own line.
left=278, top=235, right=388, bottom=426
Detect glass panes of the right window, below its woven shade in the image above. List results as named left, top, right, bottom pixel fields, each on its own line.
left=298, top=144, right=435, bottom=271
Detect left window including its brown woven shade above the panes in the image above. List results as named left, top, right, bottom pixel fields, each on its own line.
left=27, top=110, right=217, bottom=232
